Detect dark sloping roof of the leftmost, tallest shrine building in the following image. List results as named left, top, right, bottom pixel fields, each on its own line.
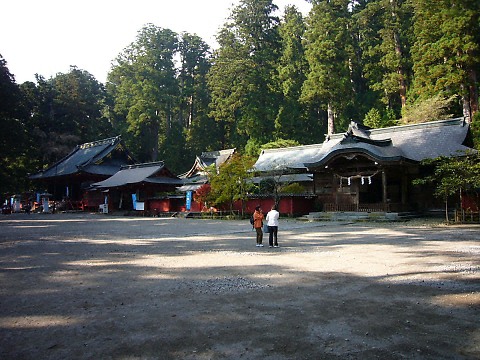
left=30, top=136, right=134, bottom=179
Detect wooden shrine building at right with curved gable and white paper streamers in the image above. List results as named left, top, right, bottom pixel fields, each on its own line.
left=254, top=118, right=475, bottom=212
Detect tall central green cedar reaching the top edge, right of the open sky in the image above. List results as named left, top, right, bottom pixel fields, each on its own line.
left=209, top=0, right=279, bottom=148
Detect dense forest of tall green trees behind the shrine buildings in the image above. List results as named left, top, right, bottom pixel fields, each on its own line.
left=0, top=0, right=480, bottom=197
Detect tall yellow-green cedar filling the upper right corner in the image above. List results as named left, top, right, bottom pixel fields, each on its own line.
left=412, top=0, right=480, bottom=119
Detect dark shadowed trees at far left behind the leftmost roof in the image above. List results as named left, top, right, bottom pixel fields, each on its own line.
left=0, top=59, right=110, bottom=197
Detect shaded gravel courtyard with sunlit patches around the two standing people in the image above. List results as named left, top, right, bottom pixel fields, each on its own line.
left=0, top=214, right=480, bottom=359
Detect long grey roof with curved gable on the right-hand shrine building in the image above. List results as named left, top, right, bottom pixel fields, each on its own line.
left=254, top=118, right=471, bottom=171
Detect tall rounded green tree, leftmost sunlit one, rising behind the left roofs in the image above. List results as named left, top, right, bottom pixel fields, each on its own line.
left=108, top=24, right=179, bottom=161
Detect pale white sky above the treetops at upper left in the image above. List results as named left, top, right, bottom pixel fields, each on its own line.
left=0, top=0, right=311, bottom=84
